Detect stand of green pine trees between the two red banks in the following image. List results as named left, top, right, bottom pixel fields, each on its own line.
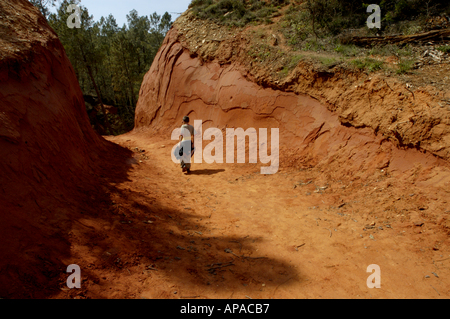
left=48, top=0, right=172, bottom=134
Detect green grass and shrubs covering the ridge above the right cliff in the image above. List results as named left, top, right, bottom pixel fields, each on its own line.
left=190, top=0, right=450, bottom=78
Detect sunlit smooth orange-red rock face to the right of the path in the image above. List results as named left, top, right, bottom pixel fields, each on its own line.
left=135, top=27, right=446, bottom=174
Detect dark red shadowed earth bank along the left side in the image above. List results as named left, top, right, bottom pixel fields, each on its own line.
left=0, top=0, right=107, bottom=298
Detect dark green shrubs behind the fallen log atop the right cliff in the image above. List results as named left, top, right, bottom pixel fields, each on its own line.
left=280, top=0, right=450, bottom=47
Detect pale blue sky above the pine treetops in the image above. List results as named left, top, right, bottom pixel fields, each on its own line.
left=51, top=0, right=191, bottom=27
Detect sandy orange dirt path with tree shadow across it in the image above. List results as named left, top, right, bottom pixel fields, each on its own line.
left=55, top=133, right=450, bottom=299
